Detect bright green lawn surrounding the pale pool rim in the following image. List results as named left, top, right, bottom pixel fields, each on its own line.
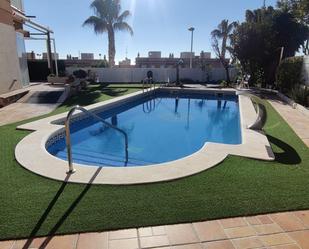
left=0, top=86, right=309, bottom=240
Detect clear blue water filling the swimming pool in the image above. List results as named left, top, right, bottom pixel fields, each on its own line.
left=47, top=93, right=241, bottom=167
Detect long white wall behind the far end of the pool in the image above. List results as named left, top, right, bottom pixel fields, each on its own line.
left=66, top=67, right=237, bottom=83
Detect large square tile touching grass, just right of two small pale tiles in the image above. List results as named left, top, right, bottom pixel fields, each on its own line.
left=166, top=224, right=199, bottom=245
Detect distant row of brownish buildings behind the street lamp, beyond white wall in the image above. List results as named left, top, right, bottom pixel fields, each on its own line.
left=135, top=51, right=222, bottom=68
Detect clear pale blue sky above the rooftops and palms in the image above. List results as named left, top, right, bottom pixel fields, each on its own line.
left=24, top=0, right=276, bottom=63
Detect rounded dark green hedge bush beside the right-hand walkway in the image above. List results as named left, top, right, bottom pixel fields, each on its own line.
left=276, top=57, right=303, bottom=93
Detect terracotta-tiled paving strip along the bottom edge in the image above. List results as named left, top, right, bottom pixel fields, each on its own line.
left=0, top=210, right=309, bottom=249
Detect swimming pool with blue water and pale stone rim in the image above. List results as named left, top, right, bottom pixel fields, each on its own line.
left=15, top=87, right=274, bottom=185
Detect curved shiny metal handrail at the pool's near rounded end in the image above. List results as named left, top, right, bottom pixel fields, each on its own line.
left=65, top=105, right=129, bottom=174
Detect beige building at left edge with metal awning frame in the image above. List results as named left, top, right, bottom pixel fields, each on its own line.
left=0, top=0, right=52, bottom=94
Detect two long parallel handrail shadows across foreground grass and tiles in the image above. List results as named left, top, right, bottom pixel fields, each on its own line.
left=22, top=168, right=102, bottom=249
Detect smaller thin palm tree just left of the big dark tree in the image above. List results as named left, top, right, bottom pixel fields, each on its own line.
left=211, top=20, right=237, bottom=84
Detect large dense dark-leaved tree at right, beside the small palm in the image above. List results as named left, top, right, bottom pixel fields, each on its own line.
left=231, top=7, right=308, bottom=87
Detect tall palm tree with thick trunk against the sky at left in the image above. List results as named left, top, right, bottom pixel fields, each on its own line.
left=83, top=0, right=133, bottom=67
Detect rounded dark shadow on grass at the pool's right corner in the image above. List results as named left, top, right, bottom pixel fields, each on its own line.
left=267, top=135, right=301, bottom=165
